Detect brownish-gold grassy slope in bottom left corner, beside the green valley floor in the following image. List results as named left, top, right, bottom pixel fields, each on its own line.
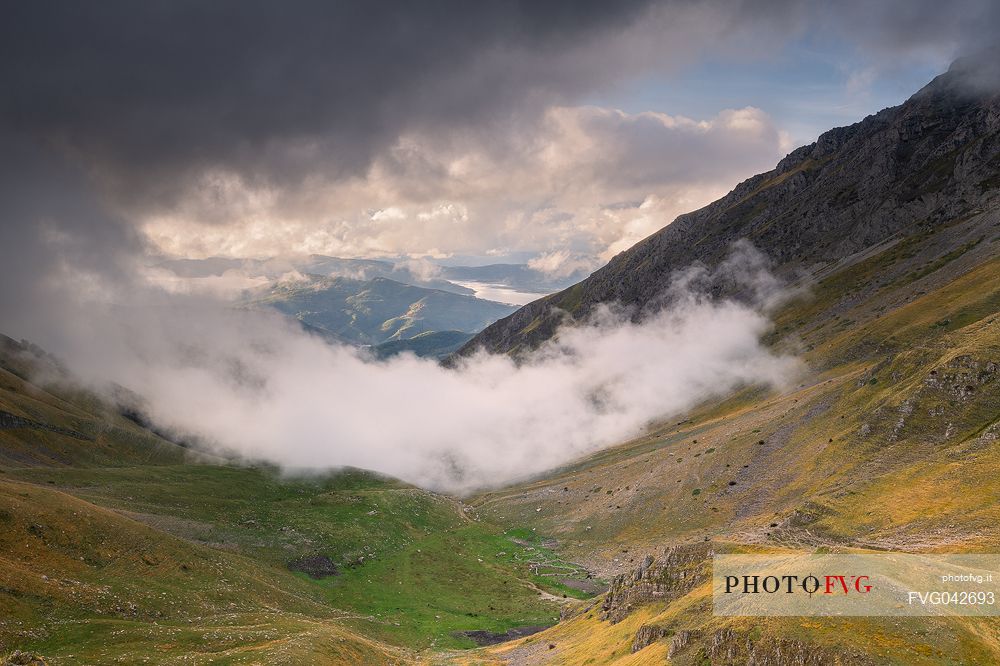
left=0, top=480, right=406, bottom=664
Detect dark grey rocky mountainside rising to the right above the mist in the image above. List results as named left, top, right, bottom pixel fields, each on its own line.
left=460, top=54, right=1000, bottom=353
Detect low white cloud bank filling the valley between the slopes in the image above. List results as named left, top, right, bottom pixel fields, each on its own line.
left=52, top=244, right=798, bottom=492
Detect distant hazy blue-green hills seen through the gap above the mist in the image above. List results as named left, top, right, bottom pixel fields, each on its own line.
left=157, top=254, right=580, bottom=357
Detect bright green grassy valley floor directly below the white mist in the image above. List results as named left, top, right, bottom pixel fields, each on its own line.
left=8, top=465, right=576, bottom=647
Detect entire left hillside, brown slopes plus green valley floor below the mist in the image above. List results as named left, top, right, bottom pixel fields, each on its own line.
left=0, top=348, right=573, bottom=664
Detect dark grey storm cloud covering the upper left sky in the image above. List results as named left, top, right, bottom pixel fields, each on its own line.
left=0, top=1, right=656, bottom=208
